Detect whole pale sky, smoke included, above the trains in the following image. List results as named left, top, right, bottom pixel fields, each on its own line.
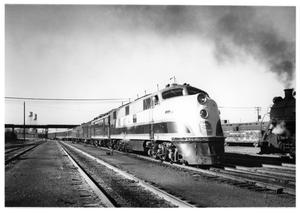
left=5, top=5, right=296, bottom=124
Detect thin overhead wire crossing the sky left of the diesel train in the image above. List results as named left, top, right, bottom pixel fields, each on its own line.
left=5, top=96, right=128, bottom=102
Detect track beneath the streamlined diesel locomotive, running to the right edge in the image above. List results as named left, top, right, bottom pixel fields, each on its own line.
left=74, top=141, right=296, bottom=195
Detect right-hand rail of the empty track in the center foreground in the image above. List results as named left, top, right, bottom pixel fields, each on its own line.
left=62, top=142, right=196, bottom=208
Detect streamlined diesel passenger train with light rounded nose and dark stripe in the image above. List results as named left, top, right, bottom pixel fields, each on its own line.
left=49, top=84, right=225, bottom=165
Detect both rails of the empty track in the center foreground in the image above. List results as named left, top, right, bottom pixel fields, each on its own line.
left=61, top=142, right=196, bottom=208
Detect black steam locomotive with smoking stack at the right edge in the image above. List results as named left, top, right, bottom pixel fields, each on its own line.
left=259, top=89, right=296, bottom=156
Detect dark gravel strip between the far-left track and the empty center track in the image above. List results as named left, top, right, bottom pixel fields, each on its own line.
left=5, top=141, right=101, bottom=207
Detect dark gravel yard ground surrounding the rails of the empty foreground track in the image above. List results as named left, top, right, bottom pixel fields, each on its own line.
left=5, top=140, right=296, bottom=207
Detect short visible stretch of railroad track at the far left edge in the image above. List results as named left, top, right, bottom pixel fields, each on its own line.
left=5, top=142, right=43, bottom=165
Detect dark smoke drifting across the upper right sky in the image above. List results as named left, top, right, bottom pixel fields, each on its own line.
left=115, top=6, right=295, bottom=87
